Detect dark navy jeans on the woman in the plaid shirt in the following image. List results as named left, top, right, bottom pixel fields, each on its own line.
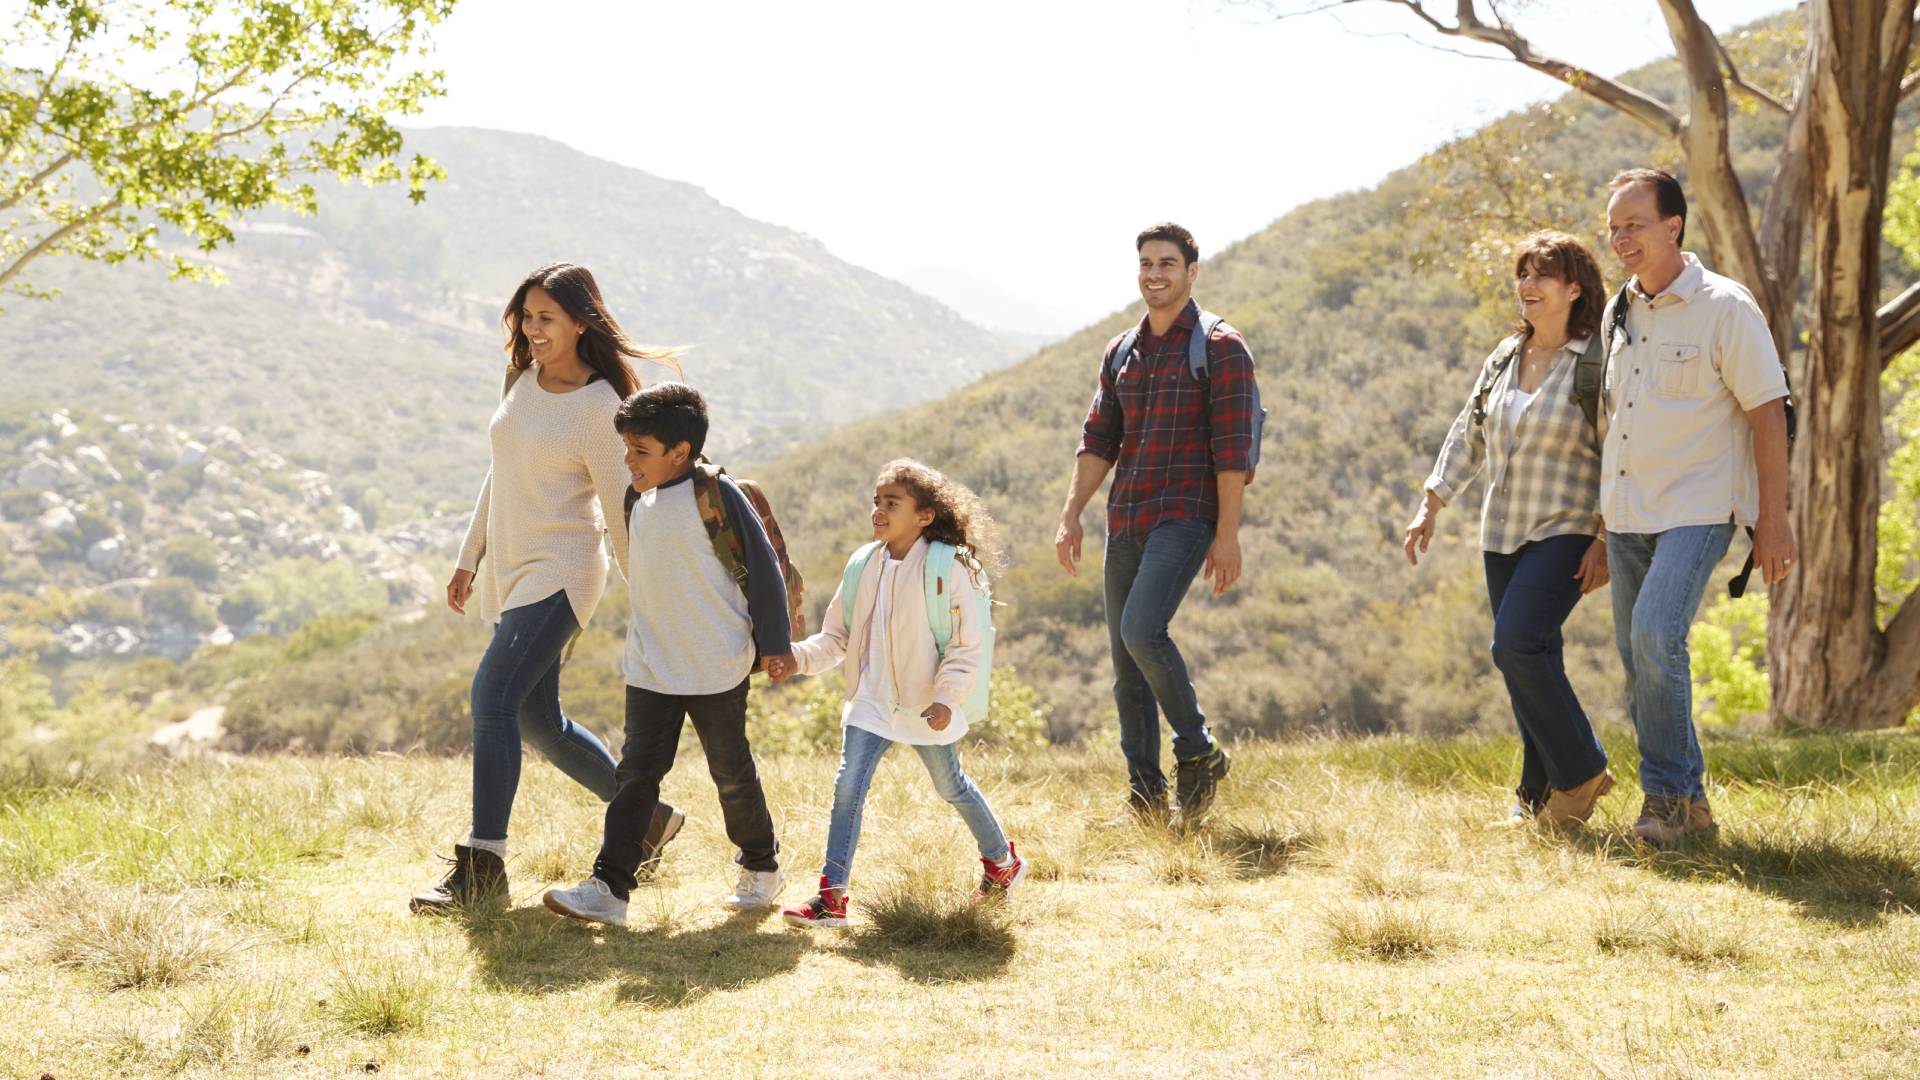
left=1484, top=536, right=1607, bottom=807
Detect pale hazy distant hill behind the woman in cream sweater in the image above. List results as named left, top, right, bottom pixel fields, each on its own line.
left=0, top=129, right=1016, bottom=521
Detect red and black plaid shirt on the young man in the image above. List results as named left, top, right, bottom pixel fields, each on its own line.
left=1079, top=300, right=1254, bottom=540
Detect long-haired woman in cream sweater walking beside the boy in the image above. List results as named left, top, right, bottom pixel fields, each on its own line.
left=411, top=263, right=684, bottom=913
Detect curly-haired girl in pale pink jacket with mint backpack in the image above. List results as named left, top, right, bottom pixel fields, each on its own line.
left=770, top=459, right=1027, bottom=926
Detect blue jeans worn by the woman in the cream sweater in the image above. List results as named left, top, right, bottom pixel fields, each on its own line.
left=470, top=590, right=614, bottom=840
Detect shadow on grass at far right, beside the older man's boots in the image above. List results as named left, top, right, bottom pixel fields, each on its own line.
left=1571, top=830, right=1920, bottom=926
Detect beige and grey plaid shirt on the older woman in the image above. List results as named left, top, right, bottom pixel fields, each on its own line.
left=1427, top=338, right=1599, bottom=555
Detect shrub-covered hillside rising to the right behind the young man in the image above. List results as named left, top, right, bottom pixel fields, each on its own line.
left=760, top=18, right=1916, bottom=734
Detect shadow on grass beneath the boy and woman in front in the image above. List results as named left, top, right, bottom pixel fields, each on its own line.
left=465, top=905, right=808, bottom=1009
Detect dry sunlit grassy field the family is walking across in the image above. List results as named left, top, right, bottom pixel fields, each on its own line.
left=0, top=734, right=1920, bottom=1080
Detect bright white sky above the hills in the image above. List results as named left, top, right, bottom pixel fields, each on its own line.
left=409, top=0, right=1788, bottom=319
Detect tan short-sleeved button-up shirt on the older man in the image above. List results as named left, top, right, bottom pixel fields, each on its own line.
left=1599, top=252, right=1788, bottom=532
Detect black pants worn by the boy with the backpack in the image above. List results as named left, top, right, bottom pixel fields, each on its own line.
left=593, top=678, right=780, bottom=899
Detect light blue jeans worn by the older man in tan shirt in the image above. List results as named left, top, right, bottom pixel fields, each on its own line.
left=1607, top=521, right=1734, bottom=799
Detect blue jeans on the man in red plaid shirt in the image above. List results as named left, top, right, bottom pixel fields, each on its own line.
left=1106, top=519, right=1213, bottom=796
